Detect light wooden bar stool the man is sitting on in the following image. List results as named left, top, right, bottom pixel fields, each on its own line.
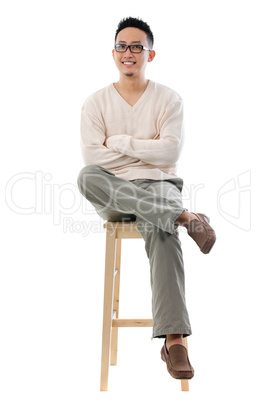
left=100, top=222, right=189, bottom=391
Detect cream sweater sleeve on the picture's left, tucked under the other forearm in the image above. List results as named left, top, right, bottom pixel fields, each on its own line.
left=80, top=106, right=138, bottom=169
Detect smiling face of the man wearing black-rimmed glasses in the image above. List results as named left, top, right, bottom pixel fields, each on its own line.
left=112, top=27, right=155, bottom=77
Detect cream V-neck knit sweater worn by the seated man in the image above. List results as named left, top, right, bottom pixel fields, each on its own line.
left=81, top=81, right=184, bottom=180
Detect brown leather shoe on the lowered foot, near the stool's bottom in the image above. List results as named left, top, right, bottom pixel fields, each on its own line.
left=161, top=340, right=194, bottom=380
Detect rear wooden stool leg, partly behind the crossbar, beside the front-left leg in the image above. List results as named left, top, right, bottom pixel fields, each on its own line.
left=110, top=239, right=122, bottom=366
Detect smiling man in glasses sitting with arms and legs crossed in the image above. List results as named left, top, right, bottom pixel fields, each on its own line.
left=78, top=17, right=216, bottom=379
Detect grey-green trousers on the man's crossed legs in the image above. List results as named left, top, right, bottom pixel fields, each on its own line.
left=77, top=165, right=192, bottom=338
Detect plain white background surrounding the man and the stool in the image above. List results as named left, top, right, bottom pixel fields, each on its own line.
left=0, top=0, right=256, bottom=402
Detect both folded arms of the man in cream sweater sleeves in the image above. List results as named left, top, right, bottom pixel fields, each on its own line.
left=81, top=101, right=183, bottom=169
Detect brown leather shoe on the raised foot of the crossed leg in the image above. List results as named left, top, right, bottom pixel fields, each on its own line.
left=187, top=212, right=216, bottom=254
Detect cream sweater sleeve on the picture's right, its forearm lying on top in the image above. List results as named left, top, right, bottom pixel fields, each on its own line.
left=107, top=100, right=184, bottom=166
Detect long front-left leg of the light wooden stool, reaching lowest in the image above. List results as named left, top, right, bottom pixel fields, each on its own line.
left=100, top=229, right=116, bottom=391
